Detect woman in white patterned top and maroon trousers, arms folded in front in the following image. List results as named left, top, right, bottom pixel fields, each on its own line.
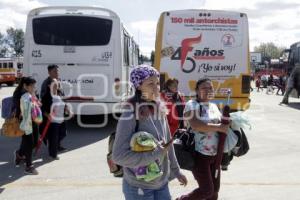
left=176, top=78, right=229, bottom=200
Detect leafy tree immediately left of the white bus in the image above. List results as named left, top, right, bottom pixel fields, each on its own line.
left=6, top=27, right=24, bottom=56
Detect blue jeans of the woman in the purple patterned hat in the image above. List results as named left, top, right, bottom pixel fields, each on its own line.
left=123, top=179, right=171, bottom=200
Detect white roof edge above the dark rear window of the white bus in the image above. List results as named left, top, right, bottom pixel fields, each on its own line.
left=28, top=6, right=119, bottom=18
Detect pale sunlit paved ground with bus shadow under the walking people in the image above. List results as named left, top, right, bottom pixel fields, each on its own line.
left=0, top=87, right=300, bottom=200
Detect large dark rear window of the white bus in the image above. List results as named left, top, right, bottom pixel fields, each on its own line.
left=32, top=16, right=112, bottom=46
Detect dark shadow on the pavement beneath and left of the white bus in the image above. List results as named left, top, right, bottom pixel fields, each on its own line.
left=0, top=115, right=117, bottom=189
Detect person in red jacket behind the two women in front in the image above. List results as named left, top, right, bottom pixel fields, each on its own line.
left=161, top=78, right=185, bottom=136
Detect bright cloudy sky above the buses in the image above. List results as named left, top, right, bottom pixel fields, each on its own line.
left=0, top=0, right=300, bottom=55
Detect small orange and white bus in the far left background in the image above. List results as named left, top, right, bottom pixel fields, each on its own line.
left=0, top=57, right=23, bottom=86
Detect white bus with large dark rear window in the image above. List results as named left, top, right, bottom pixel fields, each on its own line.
left=24, top=6, right=139, bottom=115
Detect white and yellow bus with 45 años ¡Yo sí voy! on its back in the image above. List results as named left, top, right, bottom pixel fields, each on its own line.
left=154, top=10, right=251, bottom=110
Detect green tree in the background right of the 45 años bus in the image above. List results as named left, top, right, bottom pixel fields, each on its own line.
left=254, top=42, right=286, bottom=60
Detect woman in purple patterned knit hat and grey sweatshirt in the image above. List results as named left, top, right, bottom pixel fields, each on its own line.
left=112, top=65, right=187, bottom=200
